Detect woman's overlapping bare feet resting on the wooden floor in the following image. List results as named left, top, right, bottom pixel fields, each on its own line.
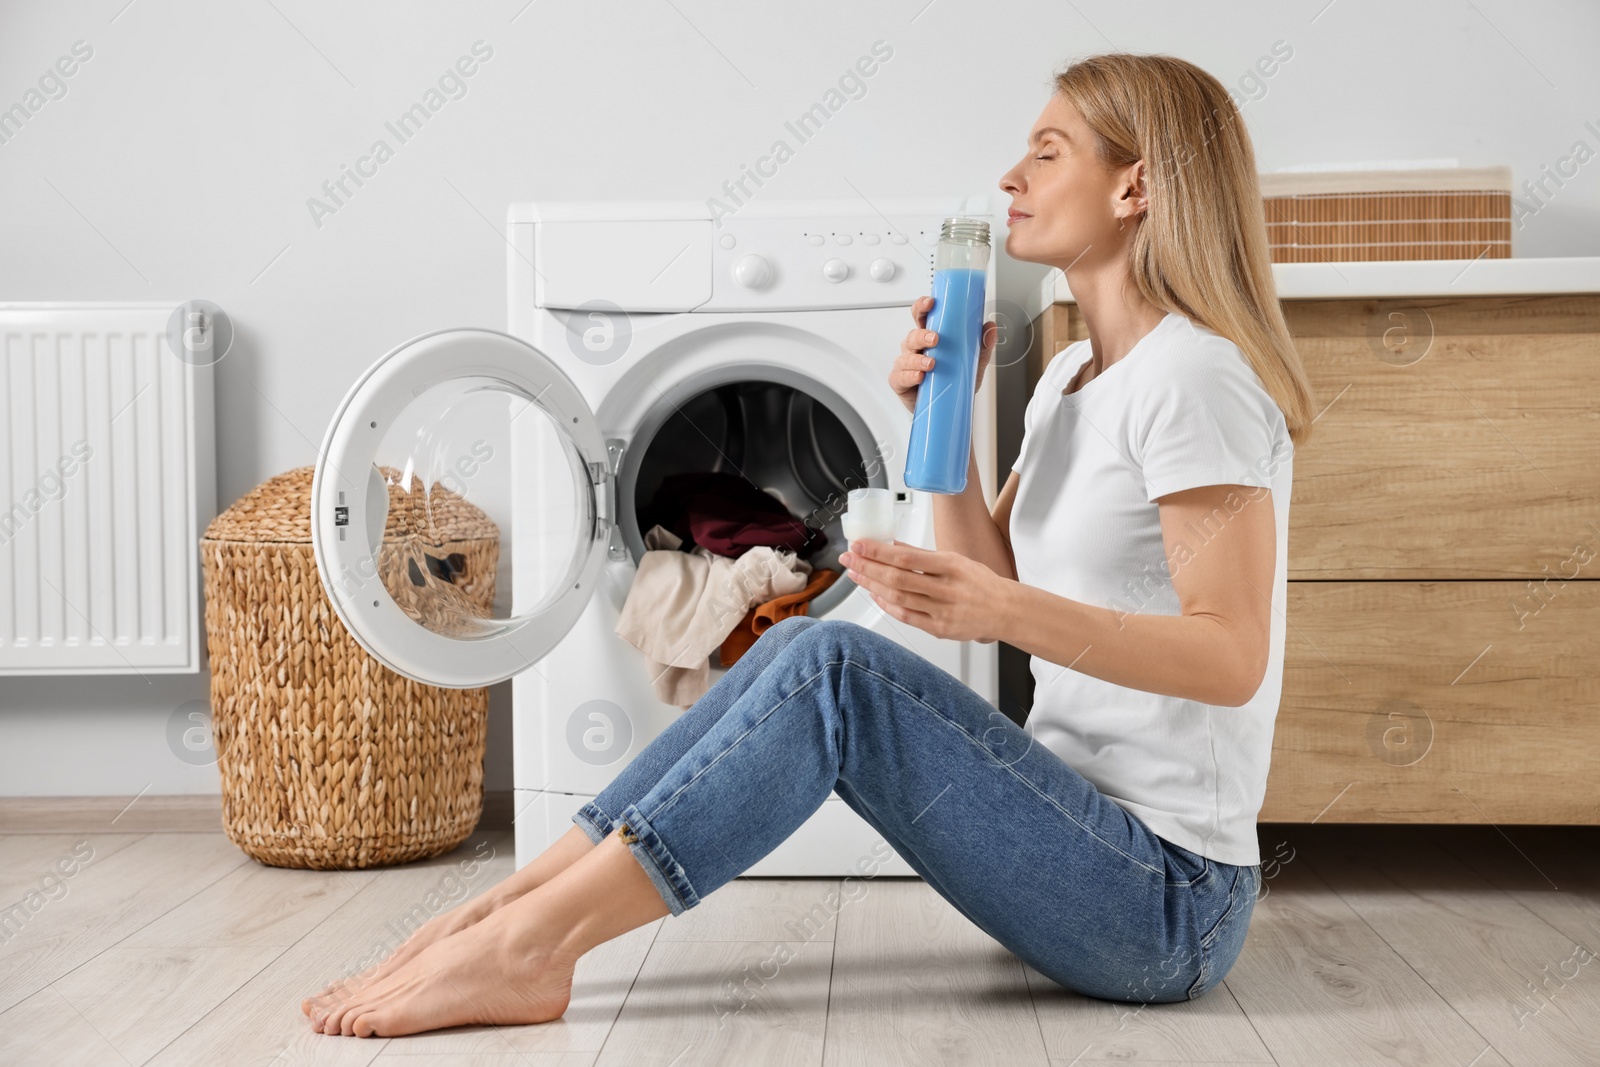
left=300, top=912, right=576, bottom=1037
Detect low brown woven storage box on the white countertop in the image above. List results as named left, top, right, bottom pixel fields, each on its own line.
left=1259, top=166, right=1512, bottom=262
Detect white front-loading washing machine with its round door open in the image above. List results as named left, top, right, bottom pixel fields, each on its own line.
left=312, top=195, right=1003, bottom=877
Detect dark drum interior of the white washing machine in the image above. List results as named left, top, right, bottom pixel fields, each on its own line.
left=624, top=381, right=888, bottom=617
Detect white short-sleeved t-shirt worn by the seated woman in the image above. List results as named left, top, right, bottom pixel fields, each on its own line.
left=1011, top=312, right=1294, bottom=865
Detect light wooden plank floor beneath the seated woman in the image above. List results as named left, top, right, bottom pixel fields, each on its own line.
left=0, top=798, right=1600, bottom=1067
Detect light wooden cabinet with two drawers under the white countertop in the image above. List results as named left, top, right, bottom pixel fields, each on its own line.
left=1029, top=289, right=1600, bottom=824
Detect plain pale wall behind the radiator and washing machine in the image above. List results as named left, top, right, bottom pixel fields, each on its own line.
left=0, top=0, right=1600, bottom=795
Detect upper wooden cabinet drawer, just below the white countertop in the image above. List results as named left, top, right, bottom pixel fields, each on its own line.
left=1283, top=296, right=1600, bottom=579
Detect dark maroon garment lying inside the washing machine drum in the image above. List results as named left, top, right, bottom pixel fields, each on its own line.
left=638, top=470, right=827, bottom=560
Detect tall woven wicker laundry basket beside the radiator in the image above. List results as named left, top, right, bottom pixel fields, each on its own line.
left=200, top=467, right=499, bottom=869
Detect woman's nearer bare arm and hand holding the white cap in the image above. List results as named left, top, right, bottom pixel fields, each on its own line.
left=840, top=485, right=1277, bottom=707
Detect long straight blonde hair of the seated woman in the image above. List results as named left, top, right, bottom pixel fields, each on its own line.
left=1056, top=53, right=1314, bottom=445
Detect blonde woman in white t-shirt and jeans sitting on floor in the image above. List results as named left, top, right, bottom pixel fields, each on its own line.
left=302, top=54, right=1310, bottom=1037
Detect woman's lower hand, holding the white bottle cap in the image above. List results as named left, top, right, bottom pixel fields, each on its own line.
left=838, top=539, right=1011, bottom=645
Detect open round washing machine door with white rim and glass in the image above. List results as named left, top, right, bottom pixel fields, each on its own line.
left=310, top=330, right=616, bottom=688
